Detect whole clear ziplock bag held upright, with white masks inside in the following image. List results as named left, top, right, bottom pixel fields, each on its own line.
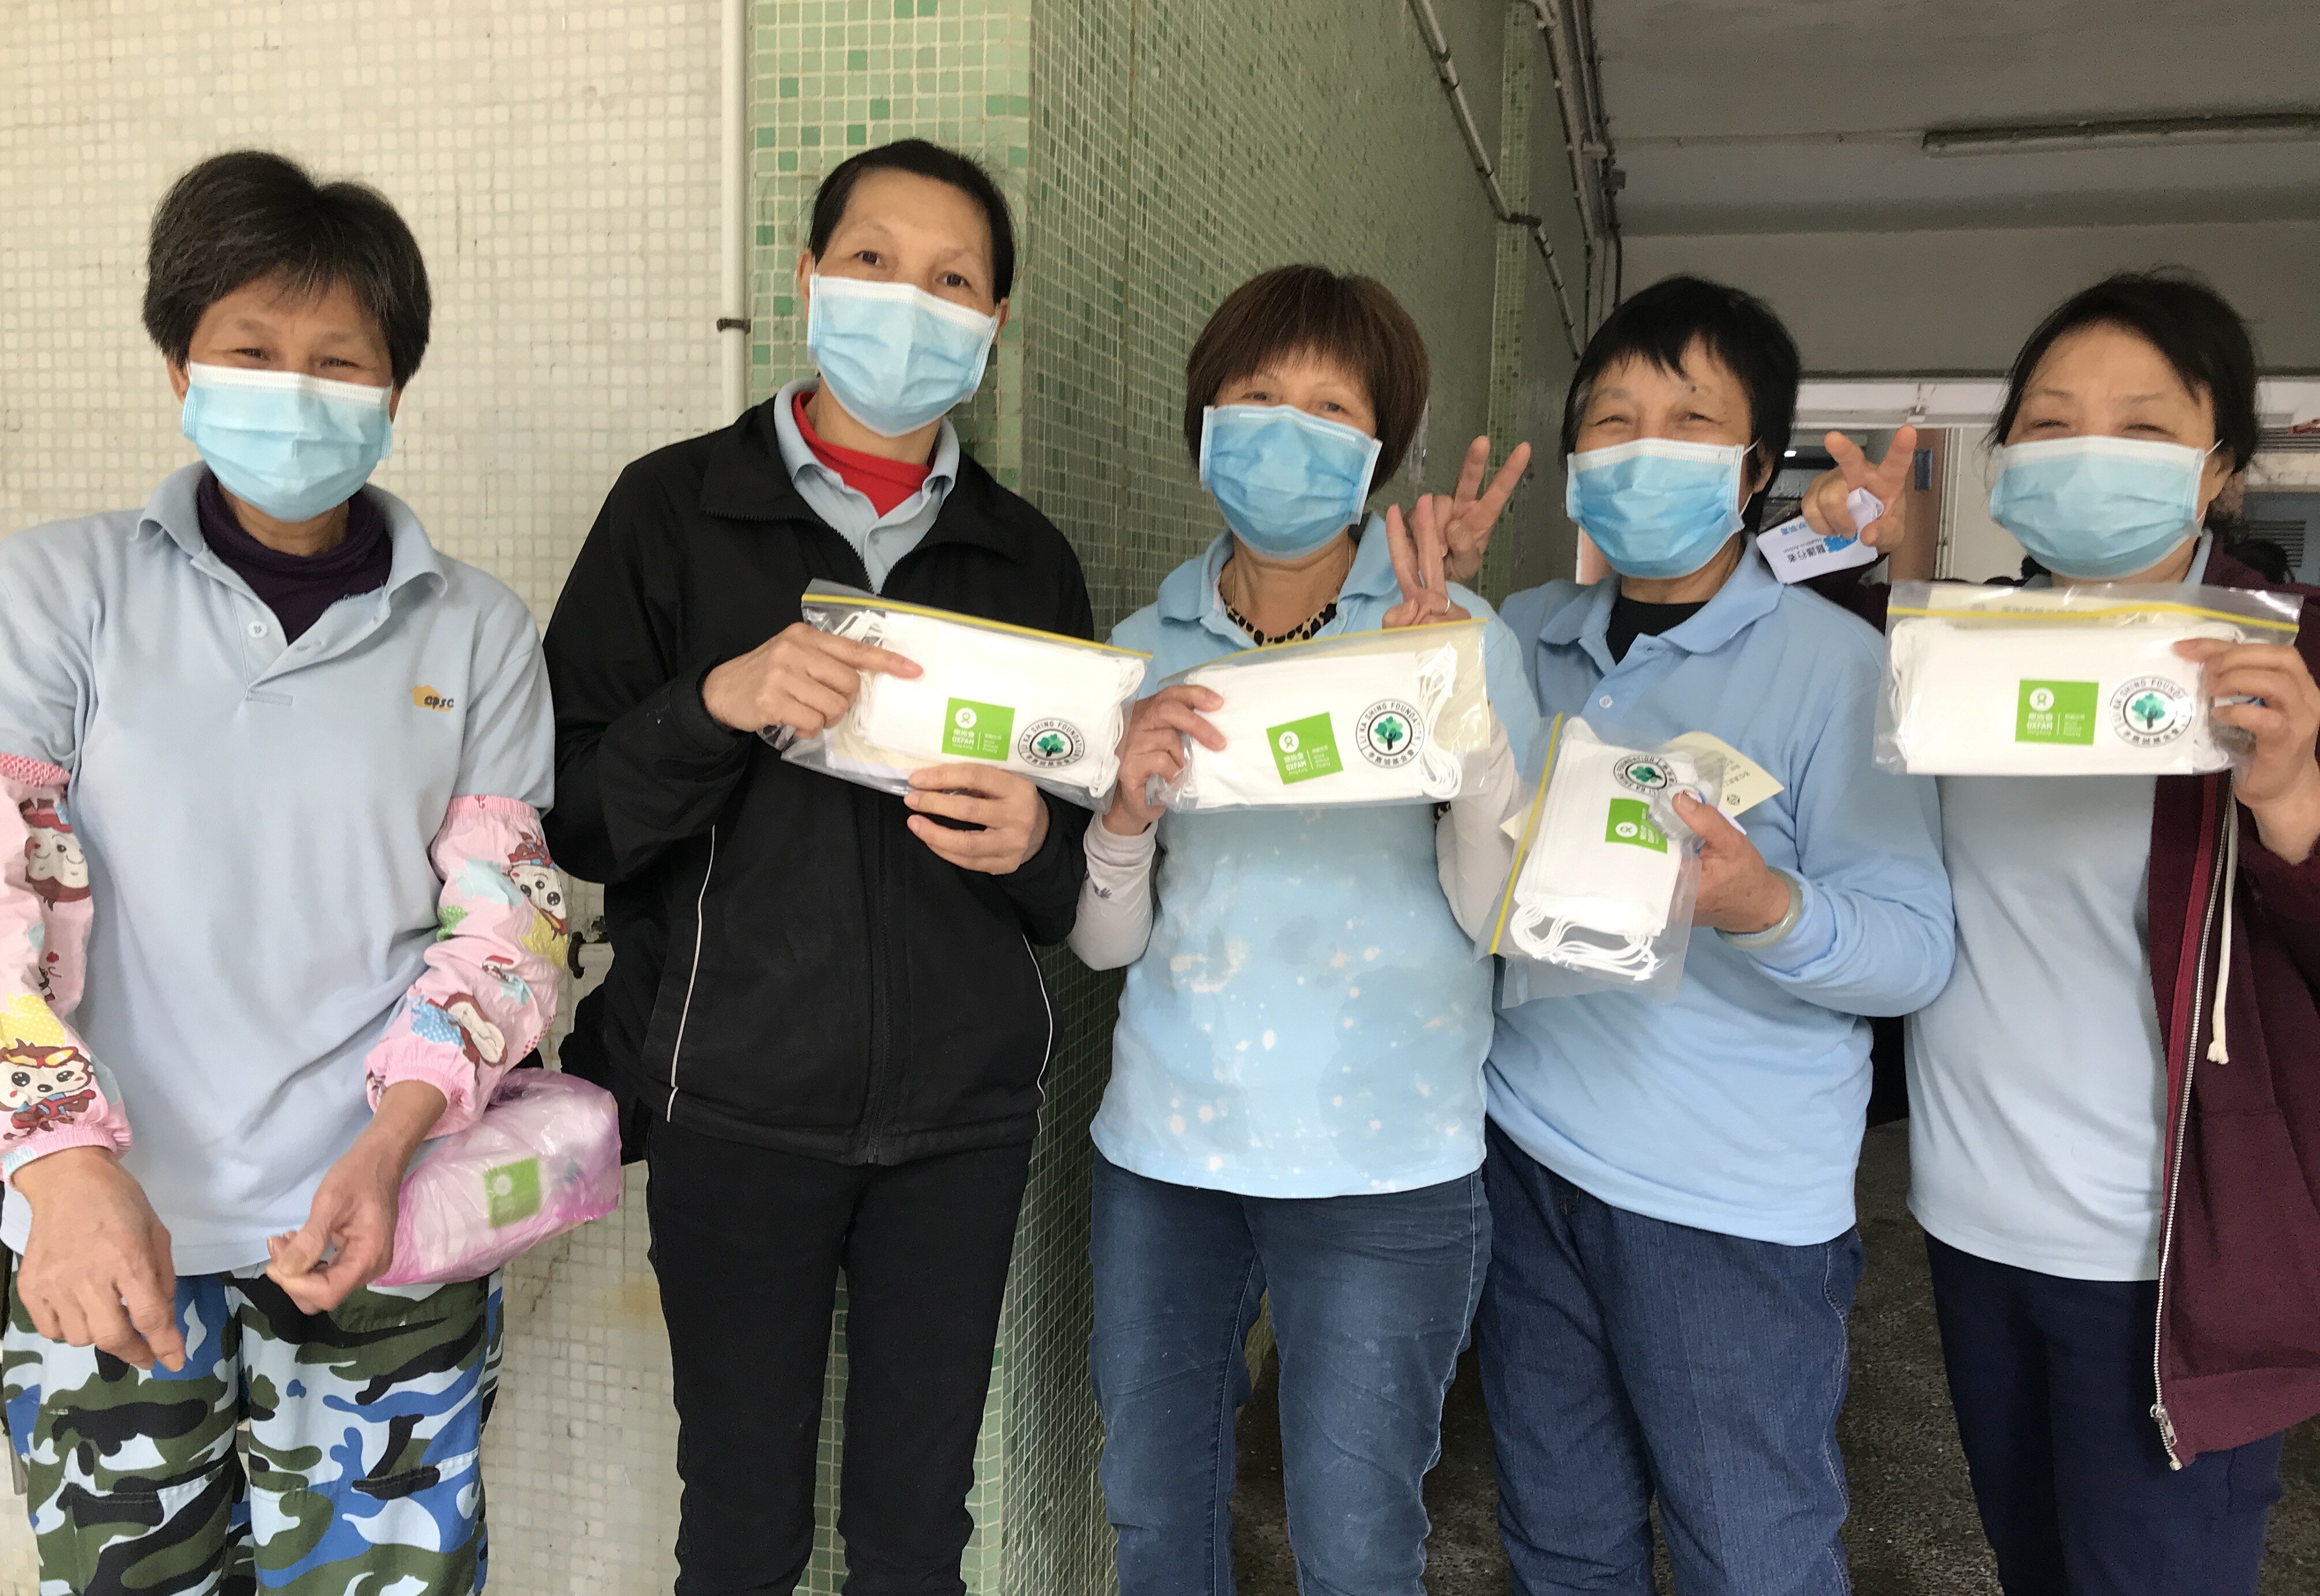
left=1482, top=714, right=1724, bottom=1002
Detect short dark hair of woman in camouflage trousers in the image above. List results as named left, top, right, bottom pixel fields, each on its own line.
left=144, top=151, right=434, bottom=387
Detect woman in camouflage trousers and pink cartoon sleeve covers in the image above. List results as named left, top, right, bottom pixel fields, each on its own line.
left=0, top=151, right=564, bottom=1596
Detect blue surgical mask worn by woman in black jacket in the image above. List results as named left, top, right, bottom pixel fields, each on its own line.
left=805, top=274, right=1000, bottom=438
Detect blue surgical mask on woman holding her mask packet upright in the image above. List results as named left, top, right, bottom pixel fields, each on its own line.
left=1564, top=438, right=1747, bottom=578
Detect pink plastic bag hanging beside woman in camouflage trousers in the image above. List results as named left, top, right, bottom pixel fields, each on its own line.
left=376, top=1070, right=619, bottom=1285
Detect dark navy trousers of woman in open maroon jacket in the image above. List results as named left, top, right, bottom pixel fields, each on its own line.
left=1926, top=1236, right=2281, bottom=1596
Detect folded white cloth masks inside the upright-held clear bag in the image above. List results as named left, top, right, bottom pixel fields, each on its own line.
left=1508, top=721, right=1701, bottom=984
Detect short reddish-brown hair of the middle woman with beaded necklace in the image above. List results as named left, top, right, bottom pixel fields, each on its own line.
left=1183, top=267, right=1434, bottom=485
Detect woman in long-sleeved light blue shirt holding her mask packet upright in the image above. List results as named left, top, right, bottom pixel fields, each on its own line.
left=1475, top=278, right=1953, bottom=1596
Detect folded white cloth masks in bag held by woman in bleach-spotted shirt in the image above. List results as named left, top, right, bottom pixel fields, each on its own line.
left=1169, top=642, right=1464, bottom=810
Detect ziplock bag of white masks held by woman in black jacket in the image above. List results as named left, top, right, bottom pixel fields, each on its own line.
left=782, top=582, right=1151, bottom=807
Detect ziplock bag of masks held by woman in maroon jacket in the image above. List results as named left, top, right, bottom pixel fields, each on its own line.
left=1877, top=582, right=2302, bottom=775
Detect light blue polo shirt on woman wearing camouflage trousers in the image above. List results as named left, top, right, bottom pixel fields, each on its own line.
left=0, top=466, right=555, bottom=1274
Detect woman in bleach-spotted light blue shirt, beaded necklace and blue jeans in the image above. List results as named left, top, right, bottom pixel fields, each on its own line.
left=1072, top=267, right=1536, bottom=1596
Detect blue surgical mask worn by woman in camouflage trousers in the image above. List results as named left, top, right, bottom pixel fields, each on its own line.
left=183, top=364, right=394, bottom=522
